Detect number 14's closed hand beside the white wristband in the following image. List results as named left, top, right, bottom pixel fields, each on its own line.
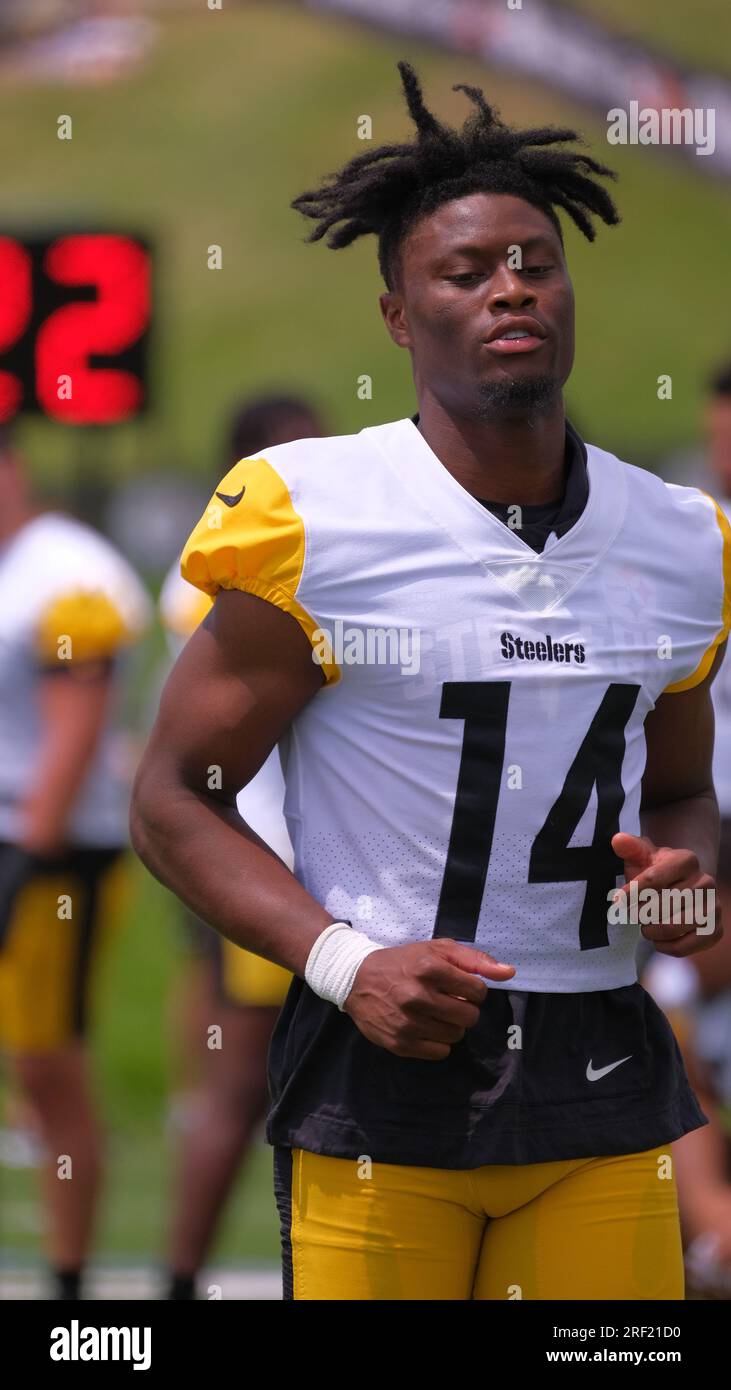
left=343, top=938, right=516, bottom=1062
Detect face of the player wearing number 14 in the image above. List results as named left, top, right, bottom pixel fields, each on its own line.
left=381, top=193, right=574, bottom=417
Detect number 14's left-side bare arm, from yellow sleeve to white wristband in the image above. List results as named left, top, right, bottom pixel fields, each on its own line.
left=131, top=592, right=334, bottom=974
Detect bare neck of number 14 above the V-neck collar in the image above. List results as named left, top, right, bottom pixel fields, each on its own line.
left=417, top=392, right=566, bottom=506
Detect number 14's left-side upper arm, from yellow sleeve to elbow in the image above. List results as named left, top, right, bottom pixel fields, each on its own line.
left=146, top=591, right=324, bottom=801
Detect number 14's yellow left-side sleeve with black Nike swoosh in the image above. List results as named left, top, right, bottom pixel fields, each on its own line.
left=181, top=459, right=340, bottom=684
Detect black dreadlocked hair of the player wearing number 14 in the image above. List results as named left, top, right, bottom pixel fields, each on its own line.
left=290, top=61, right=620, bottom=289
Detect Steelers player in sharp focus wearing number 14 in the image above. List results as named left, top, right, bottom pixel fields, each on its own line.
left=133, top=63, right=731, bottom=1300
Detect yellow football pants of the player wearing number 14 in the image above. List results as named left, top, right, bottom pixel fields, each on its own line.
left=285, top=1145, right=684, bottom=1301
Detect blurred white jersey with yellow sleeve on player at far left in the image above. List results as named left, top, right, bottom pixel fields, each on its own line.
left=0, top=513, right=150, bottom=848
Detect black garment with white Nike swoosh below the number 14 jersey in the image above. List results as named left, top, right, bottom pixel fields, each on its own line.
left=267, top=979, right=707, bottom=1169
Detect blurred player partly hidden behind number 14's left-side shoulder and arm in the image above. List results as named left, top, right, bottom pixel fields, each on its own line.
left=160, top=395, right=325, bottom=1300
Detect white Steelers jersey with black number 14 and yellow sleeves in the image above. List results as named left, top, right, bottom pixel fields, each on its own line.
left=182, top=418, right=731, bottom=992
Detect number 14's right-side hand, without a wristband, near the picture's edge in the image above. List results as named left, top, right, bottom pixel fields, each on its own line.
left=611, top=831, right=723, bottom=956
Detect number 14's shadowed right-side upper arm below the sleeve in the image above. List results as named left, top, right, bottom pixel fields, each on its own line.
left=642, top=644, right=725, bottom=809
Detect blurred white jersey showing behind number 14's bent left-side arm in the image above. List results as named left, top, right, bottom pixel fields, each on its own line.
left=160, top=562, right=295, bottom=869
